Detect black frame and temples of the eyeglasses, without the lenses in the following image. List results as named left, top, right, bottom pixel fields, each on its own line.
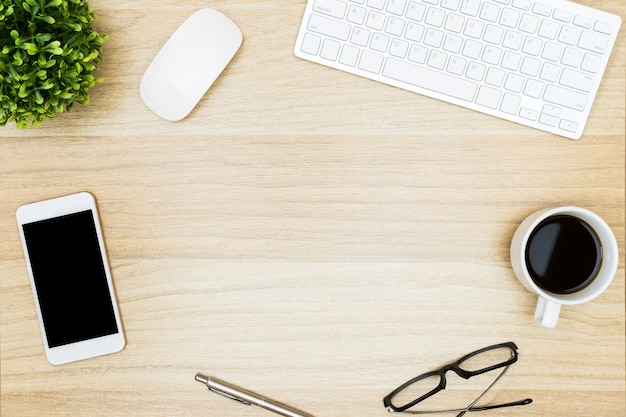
left=383, top=342, right=532, bottom=415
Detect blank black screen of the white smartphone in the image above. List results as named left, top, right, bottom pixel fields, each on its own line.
left=22, top=210, right=119, bottom=348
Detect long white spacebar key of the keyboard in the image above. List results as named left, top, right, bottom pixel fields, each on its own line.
left=383, top=58, right=477, bottom=102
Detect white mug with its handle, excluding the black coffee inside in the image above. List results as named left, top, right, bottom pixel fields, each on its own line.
left=511, top=206, right=619, bottom=328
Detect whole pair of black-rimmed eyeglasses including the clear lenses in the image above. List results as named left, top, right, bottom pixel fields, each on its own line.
left=383, top=342, right=532, bottom=417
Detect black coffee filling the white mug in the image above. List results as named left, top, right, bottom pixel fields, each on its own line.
left=526, top=215, right=602, bottom=294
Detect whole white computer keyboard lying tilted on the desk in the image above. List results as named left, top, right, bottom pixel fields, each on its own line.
left=294, top=0, right=621, bottom=139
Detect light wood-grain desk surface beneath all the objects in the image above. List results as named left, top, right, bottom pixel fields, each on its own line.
left=0, top=0, right=626, bottom=417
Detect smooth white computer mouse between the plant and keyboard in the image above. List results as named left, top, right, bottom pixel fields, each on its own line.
left=139, top=9, right=243, bottom=121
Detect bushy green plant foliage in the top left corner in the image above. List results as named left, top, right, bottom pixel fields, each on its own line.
left=0, top=0, right=107, bottom=128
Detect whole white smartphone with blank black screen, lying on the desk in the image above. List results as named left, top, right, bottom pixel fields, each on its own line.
left=16, top=193, right=126, bottom=365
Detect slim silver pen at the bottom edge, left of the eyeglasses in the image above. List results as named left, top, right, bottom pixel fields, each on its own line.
left=196, top=374, right=313, bottom=417
